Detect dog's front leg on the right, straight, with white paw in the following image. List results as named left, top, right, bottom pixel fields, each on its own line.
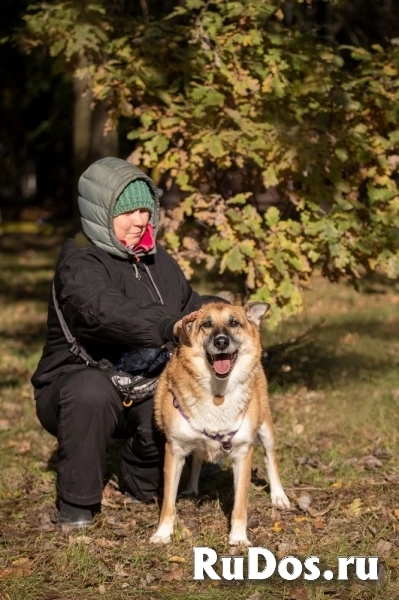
left=229, top=446, right=254, bottom=546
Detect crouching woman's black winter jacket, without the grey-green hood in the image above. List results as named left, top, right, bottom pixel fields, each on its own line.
left=32, top=239, right=223, bottom=390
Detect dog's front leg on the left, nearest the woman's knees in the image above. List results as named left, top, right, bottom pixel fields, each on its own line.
left=150, top=442, right=185, bottom=544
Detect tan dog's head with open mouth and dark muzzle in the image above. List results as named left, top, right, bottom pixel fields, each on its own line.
left=186, top=302, right=270, bottom=379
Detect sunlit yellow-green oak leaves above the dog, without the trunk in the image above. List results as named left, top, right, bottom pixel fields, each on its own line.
left=36, top=0, right=399, bottom=332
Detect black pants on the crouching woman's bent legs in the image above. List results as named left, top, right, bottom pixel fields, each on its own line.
left=35, top=367, right=164, bottom=506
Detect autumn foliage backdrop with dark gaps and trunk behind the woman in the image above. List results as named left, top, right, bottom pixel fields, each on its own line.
left=5, top=0, right=399, bottom=325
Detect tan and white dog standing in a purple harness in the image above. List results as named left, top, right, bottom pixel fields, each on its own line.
left=150, top=302, right=290, bottom=546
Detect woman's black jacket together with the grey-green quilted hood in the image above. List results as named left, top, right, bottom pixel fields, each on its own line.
left=32, top=158, right=221, bottom=389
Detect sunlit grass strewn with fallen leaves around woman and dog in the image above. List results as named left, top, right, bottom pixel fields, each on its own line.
left=0, top=232, right=399, bottom=600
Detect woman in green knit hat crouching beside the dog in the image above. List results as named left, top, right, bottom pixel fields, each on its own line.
left=32, top=158, right=225, bottom=527
